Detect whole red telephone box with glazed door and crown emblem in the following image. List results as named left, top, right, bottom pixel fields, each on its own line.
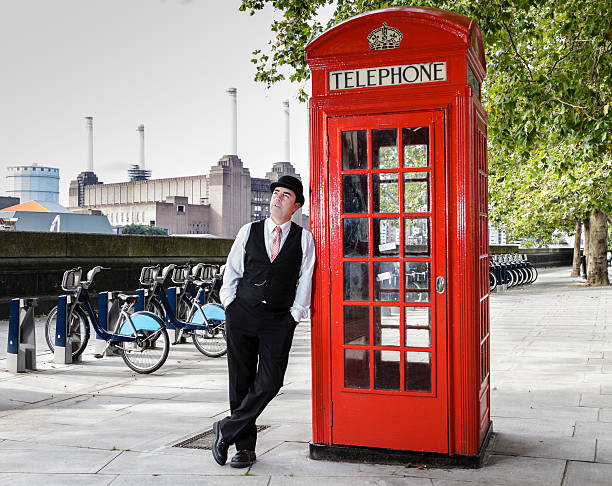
left=306, top=8, right=491, bottom=465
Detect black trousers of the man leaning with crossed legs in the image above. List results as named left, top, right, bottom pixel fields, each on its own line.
left=220, top=298, right=295, bottom=451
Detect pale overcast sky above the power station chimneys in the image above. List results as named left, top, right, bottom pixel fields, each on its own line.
left=0, top=0, right=316, bottom=205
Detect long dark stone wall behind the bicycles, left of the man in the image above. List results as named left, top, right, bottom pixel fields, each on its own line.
left=0, top=231, right=232, bottom=319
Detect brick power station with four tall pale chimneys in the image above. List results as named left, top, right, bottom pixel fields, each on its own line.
left=69, top=88, right=308, bottom=238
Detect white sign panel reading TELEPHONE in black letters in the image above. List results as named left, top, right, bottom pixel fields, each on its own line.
left=329, top=62, right=446, bottom=91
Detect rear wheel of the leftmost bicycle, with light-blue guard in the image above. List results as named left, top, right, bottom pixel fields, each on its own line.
left=116, top=312, right=170, bottom=374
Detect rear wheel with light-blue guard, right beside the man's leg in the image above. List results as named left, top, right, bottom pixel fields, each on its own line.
left=189, top=304, right=227, bottom=358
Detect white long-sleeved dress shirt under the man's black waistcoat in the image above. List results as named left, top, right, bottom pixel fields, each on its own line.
left=219, top=218, right=315, bottom=322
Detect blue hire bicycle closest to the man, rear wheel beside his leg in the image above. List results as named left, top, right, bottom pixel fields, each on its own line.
left=140, top=264, right=227, bottom=358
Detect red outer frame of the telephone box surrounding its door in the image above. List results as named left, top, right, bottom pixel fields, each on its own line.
left=306, top=8, right=490, bottom=456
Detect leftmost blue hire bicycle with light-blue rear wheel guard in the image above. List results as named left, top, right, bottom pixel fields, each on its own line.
left=45, top=266, right=170, bottom=374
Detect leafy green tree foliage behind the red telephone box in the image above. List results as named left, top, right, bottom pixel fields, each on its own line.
left=240, top=0, right=612, bottom=285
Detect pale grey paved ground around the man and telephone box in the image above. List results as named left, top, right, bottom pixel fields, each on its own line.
left=0, top=268, right=612, bottom=486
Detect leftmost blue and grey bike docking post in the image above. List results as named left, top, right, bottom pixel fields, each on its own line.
left=6, top=298, right=37, bottom=373
